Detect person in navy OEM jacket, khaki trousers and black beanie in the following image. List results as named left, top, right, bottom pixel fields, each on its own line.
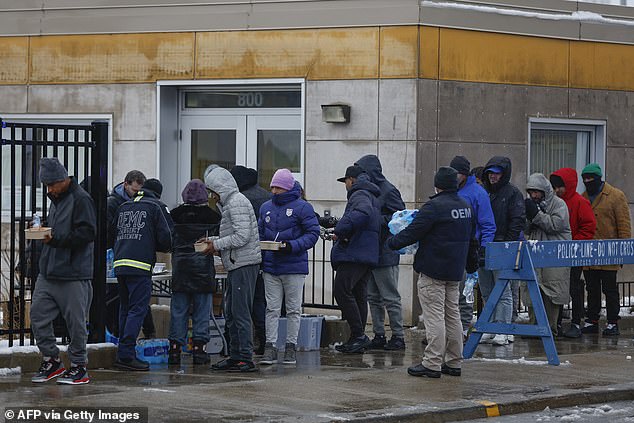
left=387, top=166, right=478, bottom=378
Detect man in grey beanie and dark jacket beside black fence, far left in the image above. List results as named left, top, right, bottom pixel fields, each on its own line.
left=31, top=158, right=97, bottom=385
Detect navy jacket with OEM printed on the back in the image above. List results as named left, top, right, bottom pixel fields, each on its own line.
left=388, top=191, right=475, bottom=282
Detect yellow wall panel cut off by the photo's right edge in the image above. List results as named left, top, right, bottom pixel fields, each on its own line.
left=570, top=41, right=634, bottom=90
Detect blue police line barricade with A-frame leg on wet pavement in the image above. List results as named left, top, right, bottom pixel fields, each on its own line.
left=463, top=239, right=634, bottom=365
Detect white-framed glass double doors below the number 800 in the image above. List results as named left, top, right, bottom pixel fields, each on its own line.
left=179, top=114, right=303, bottom=189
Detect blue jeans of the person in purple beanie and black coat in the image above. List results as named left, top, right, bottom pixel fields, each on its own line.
left=168, top=292, right=212, bottom=345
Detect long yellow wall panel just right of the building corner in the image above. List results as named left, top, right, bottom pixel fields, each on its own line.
left=439, top=28, right=569, bottom=87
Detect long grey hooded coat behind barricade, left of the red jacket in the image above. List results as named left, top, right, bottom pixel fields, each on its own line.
left=526, top=173, right=572, bottom=304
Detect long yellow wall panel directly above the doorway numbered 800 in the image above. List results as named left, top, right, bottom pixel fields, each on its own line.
left=196, top=28, right=379, bottom=80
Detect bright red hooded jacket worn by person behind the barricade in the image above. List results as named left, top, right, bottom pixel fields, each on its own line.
left=553, top=167, right=597, bottom=240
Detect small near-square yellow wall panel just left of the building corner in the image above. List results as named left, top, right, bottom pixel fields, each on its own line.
left=379, top=26, right=419, bottom=78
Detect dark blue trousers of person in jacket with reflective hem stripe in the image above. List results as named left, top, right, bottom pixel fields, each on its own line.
left=117, top=274, right=152, bottom=360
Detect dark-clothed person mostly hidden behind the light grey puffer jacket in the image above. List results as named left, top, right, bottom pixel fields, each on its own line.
left=230, top=165, right=271, bottom=355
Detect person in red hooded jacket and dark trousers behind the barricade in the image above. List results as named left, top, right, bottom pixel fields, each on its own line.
left=550, top=167, right=597, bottom=338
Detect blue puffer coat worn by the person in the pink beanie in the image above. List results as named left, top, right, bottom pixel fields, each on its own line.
left=258, top=182, right=319, bottom=275
